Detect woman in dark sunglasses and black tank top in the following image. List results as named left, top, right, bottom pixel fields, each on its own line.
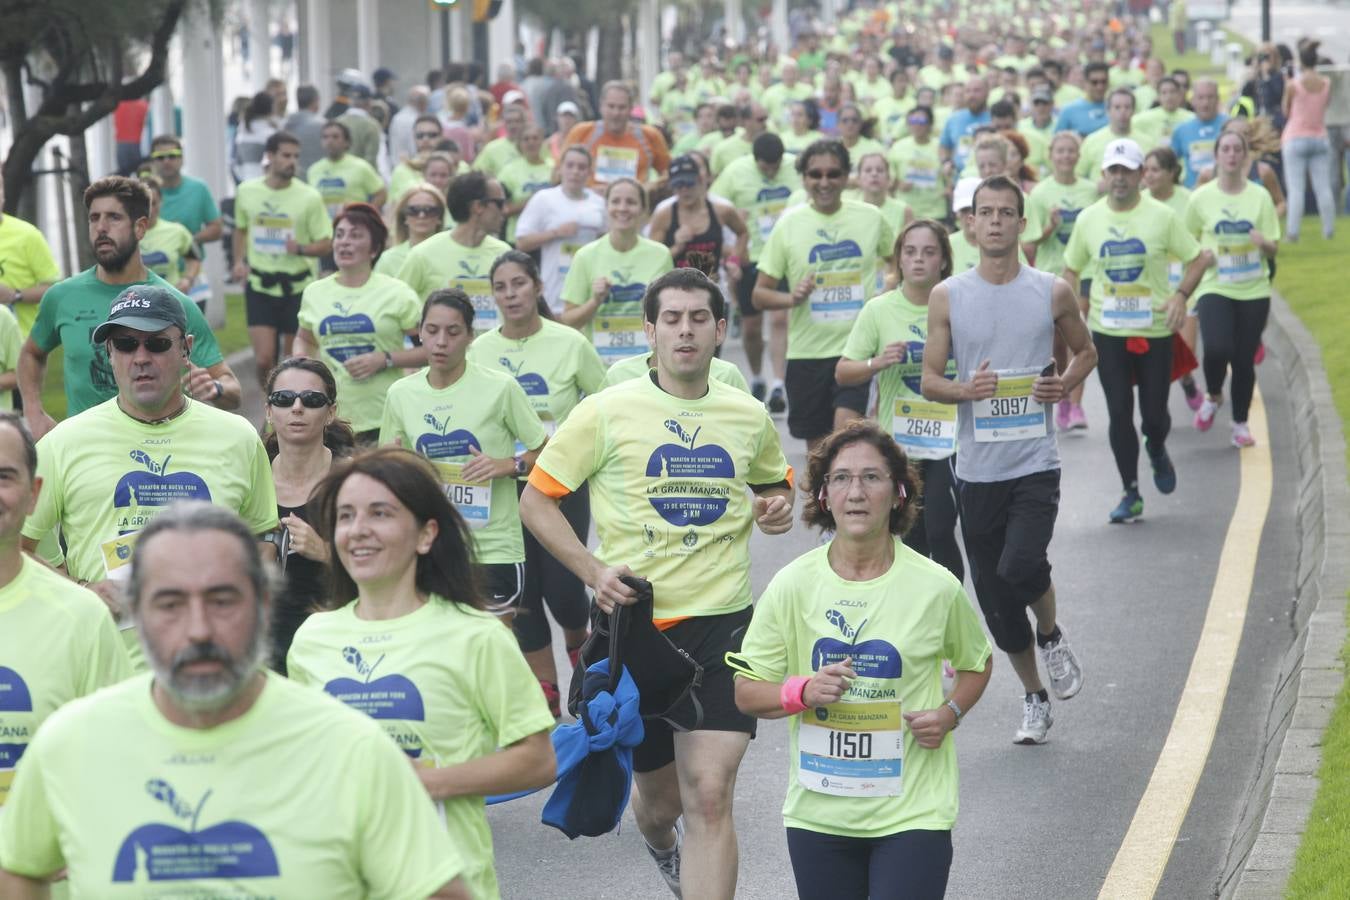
left=263, top=356, right=356, bottom=675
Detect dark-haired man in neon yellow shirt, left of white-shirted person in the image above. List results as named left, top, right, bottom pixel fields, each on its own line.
left=398, top=173, right=510, bottom=331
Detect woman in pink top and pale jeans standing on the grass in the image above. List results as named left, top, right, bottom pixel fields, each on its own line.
left=1281, top=40, right=1337, bottom=242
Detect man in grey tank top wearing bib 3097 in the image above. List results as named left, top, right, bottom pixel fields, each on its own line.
left=922, top=175, right=1096, bottom=743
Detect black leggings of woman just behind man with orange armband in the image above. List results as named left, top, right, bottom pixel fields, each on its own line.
left=512, top=484, right=590, bottom=653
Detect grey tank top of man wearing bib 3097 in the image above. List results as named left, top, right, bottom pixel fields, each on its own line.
left=944, top=266, right=1060, bottom=482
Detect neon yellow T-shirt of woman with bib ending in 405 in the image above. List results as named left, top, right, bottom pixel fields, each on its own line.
left=379, top=363, right=548, bottom=563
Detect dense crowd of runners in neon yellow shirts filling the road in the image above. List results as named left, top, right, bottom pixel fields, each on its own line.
left=0, top=0, right=1296, bottom=900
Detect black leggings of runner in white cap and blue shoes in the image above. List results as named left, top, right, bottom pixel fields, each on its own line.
left=1092, top=332, right=1172, bottom=491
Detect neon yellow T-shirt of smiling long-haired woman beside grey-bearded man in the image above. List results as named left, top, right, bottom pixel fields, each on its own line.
left=286, top=595, right=554, bottom=899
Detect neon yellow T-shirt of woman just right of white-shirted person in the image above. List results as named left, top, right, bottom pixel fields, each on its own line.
left=563, top=235, right=675, bottom=366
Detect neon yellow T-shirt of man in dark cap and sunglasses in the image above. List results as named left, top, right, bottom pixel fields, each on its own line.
left=23, top=399, right=277, bottom=585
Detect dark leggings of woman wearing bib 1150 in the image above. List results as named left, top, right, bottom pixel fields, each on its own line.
left=787, top=828, right=952, bottom=900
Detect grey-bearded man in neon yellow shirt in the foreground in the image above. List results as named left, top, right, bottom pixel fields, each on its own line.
left=0, top=503, right=470, bottom=900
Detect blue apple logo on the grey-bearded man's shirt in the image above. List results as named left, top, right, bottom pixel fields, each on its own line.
left=112, top=779, right=281, bottom=881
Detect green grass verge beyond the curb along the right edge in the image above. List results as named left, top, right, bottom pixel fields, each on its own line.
left=1276, top=234, right=1350, bottom=900
